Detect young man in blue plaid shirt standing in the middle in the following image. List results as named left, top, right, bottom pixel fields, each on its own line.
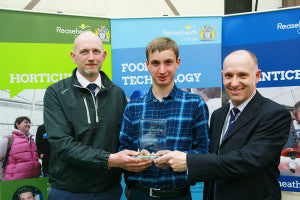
left=119, top=37, right=209, bottom=200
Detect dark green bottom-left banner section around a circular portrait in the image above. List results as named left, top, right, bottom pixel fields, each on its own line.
left=0, top=178, right=50, bottom=200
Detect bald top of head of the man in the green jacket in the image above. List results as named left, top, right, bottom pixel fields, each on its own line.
left=73, top=31, right=103, bottom=53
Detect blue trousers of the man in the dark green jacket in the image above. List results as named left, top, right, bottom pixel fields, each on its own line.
left=48, top=184, right=123, bottom=200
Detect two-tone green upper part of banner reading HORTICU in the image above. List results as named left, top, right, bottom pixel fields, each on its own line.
left=0, top=9, right=112, bottom=98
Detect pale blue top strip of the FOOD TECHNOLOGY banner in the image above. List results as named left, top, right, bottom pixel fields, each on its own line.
left=111, top=17, right=222, bottom=49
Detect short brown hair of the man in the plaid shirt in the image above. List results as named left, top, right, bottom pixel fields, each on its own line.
left=146, top=37, right=179, bottom=61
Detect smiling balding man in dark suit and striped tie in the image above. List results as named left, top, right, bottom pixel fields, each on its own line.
left=155, top=50, right=291, bottom=200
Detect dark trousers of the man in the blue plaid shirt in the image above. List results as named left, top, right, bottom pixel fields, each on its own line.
left=128, top=187, right=192, bottom=200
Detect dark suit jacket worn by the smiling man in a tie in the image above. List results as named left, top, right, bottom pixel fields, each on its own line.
left=187, top=92, right=291, bottom=200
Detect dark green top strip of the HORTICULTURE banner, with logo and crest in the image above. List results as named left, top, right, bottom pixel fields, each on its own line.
left=0, top=9, right=111, bottom=44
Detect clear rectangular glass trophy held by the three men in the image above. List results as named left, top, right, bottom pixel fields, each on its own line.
left=134, top=119, right=167, bottom=159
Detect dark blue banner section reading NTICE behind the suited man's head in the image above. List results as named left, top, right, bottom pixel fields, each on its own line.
left=222, top=8, right=300, bottom=87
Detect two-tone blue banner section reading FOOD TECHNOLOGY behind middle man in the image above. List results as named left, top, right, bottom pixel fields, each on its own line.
left=111, top=17, right=222, bottom=98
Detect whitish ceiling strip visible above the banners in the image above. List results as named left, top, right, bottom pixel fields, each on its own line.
left=0, top=0, right=282, bottom=18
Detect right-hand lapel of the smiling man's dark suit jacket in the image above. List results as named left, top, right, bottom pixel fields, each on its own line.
left=222, top=91, right=263, bottom=144
